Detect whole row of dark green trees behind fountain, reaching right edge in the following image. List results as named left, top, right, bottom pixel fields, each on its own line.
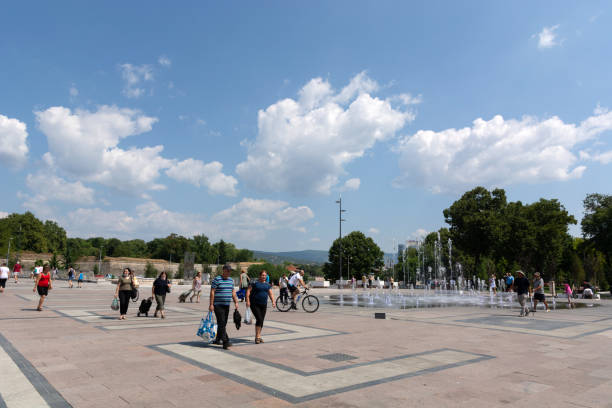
left=393, top=187, right=612, bottom=290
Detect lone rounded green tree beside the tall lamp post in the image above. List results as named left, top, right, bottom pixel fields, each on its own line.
left=323, top=231, right=384, bottom=279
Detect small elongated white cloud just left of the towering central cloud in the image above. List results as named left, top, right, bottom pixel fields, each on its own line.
left=166, top=159, right=238, bottom=196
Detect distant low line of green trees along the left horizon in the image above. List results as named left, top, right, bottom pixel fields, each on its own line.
left=0, top=212, right=254, bottom=265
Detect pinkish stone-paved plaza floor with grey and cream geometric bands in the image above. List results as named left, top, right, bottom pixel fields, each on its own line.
left=0, top=281, right=612, bottom=408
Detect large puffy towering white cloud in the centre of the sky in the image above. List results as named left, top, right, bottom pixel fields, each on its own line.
left=236, top=73, right=413, bottom=194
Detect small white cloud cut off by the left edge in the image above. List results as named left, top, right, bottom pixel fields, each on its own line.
left=0, top=115, right=29, bottom=168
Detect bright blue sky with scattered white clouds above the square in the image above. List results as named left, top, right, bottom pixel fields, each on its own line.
left=0, top=1, right=612, bottom=251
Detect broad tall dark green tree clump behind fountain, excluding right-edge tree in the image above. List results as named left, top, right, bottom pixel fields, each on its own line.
left=442, top=187, right=576, bottom=280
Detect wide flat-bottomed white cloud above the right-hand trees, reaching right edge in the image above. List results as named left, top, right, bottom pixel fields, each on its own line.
left=394, top=109, right=612, bottom=192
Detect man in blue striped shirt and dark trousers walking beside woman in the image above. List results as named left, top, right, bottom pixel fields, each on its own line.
left=208, top=264, right=238, bottom=350
